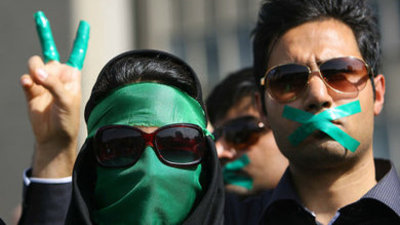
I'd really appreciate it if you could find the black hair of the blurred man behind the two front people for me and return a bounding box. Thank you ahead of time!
[206,68,257,126]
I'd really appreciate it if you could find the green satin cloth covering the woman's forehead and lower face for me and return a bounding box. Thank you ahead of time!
[88,83,207,225]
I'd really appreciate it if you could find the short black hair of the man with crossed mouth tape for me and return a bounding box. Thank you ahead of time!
[253,0,381,105]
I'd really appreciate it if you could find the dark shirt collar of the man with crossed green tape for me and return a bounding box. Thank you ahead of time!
[263,159,400,216]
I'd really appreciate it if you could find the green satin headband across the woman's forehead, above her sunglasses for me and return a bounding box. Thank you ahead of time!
[87,83,210,138]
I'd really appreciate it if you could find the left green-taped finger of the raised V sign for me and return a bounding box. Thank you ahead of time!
[34,11,60,63]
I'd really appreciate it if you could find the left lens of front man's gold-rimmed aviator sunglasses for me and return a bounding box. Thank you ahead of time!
[266,64,309,102]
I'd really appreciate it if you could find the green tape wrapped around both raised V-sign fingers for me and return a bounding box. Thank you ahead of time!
[34,11,90,70]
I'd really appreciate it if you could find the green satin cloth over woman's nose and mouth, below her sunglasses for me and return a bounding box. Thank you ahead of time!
[93,147,202,225]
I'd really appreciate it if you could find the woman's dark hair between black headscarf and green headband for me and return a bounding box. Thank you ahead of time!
[85,50,204,121]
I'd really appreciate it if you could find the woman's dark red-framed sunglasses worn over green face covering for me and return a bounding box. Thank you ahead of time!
[94,123,206,168]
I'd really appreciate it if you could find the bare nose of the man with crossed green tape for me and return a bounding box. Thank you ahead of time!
[304,71,333,113]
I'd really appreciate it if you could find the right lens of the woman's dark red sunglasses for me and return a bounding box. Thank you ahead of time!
[155,126,205,165]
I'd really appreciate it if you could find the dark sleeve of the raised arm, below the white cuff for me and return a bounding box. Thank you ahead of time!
[18,171,72,225]
